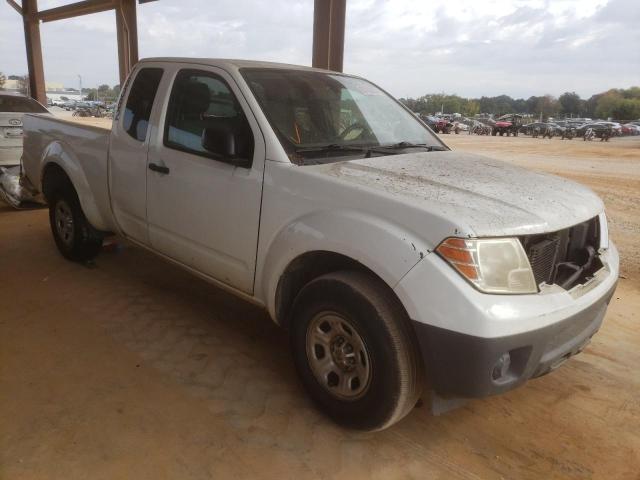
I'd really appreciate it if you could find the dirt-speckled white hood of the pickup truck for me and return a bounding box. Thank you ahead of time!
[311,151,604,236]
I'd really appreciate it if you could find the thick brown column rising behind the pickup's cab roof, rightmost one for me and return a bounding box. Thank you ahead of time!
[312,0,347,72]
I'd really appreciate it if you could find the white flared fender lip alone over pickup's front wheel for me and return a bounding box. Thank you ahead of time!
[255,210,429,319]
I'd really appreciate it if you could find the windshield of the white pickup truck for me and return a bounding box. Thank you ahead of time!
[242,69,445,164]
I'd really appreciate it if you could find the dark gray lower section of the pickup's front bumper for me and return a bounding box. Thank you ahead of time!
[413,285,616,398]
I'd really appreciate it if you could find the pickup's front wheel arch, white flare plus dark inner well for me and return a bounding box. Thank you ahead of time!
[254,210,430,325]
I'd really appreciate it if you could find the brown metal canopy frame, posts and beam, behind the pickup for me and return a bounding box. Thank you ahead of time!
[7,0,347,104]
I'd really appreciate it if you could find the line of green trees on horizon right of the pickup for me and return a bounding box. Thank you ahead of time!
[400,87,640,120]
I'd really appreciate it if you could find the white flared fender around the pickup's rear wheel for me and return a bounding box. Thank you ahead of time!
[40,140,114,231]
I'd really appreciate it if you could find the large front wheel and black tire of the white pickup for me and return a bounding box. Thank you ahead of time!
[290,271,424,431]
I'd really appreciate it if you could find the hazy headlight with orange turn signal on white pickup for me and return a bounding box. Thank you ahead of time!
[436,237,538,293]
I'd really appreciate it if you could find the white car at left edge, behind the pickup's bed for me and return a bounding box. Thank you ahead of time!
[0,92,49,167]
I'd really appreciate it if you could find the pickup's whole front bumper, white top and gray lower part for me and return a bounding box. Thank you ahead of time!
[396,244,619,398]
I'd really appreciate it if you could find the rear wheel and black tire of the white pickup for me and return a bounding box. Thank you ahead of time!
[47,184,103,262]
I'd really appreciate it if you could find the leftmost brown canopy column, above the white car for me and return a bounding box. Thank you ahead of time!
[22,0,47,105]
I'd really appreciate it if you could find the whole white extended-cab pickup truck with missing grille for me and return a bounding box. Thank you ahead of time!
[23,58,619,430]
